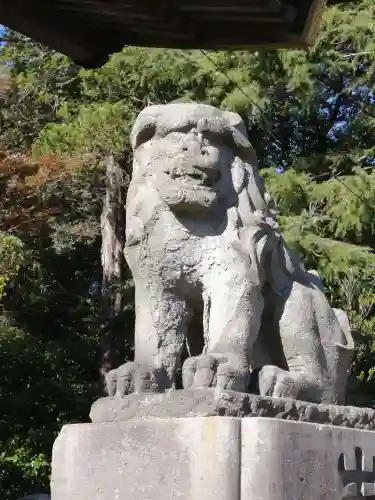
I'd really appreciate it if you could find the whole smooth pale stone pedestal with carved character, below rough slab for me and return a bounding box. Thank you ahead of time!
[52,417,375,500]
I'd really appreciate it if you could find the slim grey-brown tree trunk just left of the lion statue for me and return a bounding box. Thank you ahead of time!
[100,155,125,393]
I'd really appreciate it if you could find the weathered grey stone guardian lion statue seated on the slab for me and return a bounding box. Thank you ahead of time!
[107,104,353,404]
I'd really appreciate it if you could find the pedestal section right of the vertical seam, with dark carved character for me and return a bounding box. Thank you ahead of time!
[241,418,375,500]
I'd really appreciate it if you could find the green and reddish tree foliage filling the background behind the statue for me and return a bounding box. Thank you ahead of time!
[0,0,375,494]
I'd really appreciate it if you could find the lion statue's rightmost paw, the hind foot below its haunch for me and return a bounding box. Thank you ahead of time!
[259,365,322,403]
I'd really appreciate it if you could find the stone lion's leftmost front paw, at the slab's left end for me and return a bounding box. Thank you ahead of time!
[106,361,170,397]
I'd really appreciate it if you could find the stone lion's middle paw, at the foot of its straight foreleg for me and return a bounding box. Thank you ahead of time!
[182,354,250,392]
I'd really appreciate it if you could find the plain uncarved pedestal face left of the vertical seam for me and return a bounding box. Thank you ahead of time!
[51,418,241,500]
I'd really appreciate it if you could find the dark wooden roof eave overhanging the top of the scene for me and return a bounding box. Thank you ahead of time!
[0,0,328,67]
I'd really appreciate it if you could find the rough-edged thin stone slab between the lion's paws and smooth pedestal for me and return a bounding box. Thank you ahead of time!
[90,388,375,431]
